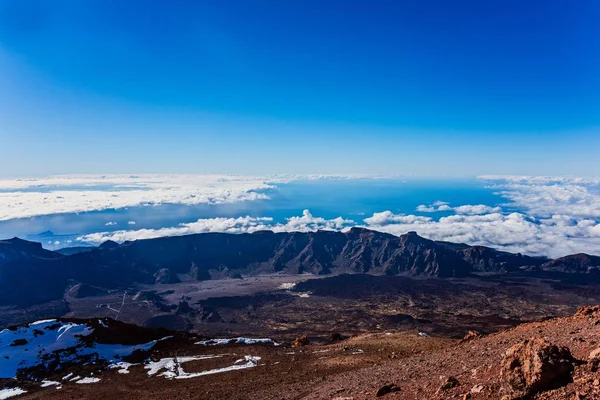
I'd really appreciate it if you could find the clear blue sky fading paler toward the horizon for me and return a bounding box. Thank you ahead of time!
[0,0,600,175]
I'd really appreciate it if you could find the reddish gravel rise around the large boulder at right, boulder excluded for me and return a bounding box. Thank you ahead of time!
[296,313,600,399]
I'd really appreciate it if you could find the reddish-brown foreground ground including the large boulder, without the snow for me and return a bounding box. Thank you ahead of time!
[7,307,600,400]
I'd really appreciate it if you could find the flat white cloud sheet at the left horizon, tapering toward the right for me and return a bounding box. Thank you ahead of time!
[0,175,373,221]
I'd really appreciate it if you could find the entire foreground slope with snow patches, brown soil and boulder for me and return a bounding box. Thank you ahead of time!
[0,306,600,400]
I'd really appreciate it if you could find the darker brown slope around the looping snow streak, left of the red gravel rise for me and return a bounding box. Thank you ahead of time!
[20,332,454,400]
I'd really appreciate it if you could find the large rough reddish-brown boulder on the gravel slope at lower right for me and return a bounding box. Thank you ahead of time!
[502,338,575,398]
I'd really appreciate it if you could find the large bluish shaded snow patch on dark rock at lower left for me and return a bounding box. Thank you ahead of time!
[0,320,156,380]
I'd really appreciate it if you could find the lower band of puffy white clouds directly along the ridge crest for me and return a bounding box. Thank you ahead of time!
[77,205,600,257]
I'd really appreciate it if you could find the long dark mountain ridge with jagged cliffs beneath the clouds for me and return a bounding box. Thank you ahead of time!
[0,228,600,305]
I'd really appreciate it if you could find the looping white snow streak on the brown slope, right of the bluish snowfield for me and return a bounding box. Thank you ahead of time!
[144,354,260,379]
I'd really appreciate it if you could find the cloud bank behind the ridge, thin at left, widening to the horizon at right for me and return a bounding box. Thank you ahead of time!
[79,176,600,257]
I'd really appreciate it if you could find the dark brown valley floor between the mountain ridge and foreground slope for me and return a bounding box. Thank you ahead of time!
[54,275,600,340]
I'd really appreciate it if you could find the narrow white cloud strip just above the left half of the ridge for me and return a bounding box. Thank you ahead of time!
[77,210,355,244]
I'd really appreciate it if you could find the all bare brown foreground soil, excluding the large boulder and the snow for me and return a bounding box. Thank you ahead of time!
[16,312,600,400]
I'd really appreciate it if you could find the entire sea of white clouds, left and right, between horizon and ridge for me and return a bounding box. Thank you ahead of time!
[0,175,600,257]
